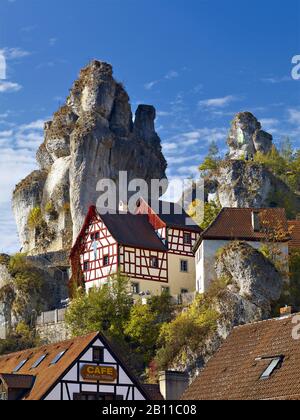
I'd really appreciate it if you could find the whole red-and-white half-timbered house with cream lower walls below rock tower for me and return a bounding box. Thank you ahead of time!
[71,200,201,296]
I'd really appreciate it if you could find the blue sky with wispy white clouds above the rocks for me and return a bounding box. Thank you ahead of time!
[0,0,300,252]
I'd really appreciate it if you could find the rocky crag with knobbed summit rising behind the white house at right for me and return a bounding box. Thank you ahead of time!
[205,112,300,217]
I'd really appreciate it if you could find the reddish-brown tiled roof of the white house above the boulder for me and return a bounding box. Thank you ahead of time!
[201,207,290,242]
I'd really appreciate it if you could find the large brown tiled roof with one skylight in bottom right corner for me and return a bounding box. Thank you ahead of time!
[182,316,300,400]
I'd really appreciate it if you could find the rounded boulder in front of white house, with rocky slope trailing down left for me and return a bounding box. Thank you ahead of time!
[171,242,284,378]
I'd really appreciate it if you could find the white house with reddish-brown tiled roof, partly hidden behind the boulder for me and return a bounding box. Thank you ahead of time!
[194,208,290,293]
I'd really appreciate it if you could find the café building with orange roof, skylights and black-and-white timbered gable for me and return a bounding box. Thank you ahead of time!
[0,333,162,401]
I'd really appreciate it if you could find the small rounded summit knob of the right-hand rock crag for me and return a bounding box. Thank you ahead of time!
[227,112,273,159]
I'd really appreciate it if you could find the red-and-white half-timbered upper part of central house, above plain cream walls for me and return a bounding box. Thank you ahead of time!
[71,200,200,287]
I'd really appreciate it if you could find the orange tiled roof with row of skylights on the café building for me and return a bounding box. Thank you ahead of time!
[0,333,152,400]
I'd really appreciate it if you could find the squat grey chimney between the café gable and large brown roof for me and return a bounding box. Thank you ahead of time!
[159,371,189,401]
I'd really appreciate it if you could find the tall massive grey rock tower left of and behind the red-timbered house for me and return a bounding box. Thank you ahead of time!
[13,61,167,254]
